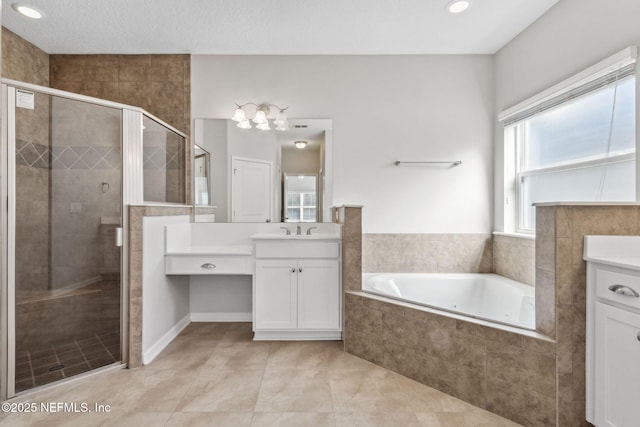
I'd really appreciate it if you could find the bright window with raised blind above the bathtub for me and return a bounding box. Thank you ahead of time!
[504,49,636,232]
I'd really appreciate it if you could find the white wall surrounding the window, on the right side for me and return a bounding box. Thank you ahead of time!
[494,0,640,230]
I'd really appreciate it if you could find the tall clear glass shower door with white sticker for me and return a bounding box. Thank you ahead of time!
[8,88,122,393]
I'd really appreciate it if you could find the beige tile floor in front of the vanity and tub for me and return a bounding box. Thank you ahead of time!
[0,323,517,427]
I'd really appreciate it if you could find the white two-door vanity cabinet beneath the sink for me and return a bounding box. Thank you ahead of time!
[253,241,342,340]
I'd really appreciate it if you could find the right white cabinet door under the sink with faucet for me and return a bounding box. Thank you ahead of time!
[298,260,340,329]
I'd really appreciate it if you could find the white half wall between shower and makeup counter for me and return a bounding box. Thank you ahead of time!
[142,216,190,364]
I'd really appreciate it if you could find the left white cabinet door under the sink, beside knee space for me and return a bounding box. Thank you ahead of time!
[255,259,298,329]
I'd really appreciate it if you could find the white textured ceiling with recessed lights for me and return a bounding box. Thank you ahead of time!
[2,0,558,55]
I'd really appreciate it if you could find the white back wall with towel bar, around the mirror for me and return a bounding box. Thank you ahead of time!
[191,55,494,233]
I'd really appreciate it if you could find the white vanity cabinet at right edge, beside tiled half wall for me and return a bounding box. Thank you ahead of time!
[585,236,640,427]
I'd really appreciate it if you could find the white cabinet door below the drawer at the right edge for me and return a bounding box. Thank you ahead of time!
[594,302,640,427]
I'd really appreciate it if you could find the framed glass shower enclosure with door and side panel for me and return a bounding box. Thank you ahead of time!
[1,81,186,398]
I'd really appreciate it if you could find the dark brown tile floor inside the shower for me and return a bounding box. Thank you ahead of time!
[16,332,120,392]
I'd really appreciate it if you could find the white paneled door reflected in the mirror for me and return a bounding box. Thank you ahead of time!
[231,157,273,222]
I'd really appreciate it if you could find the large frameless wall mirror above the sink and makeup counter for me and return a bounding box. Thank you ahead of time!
[194,119,333,222]
